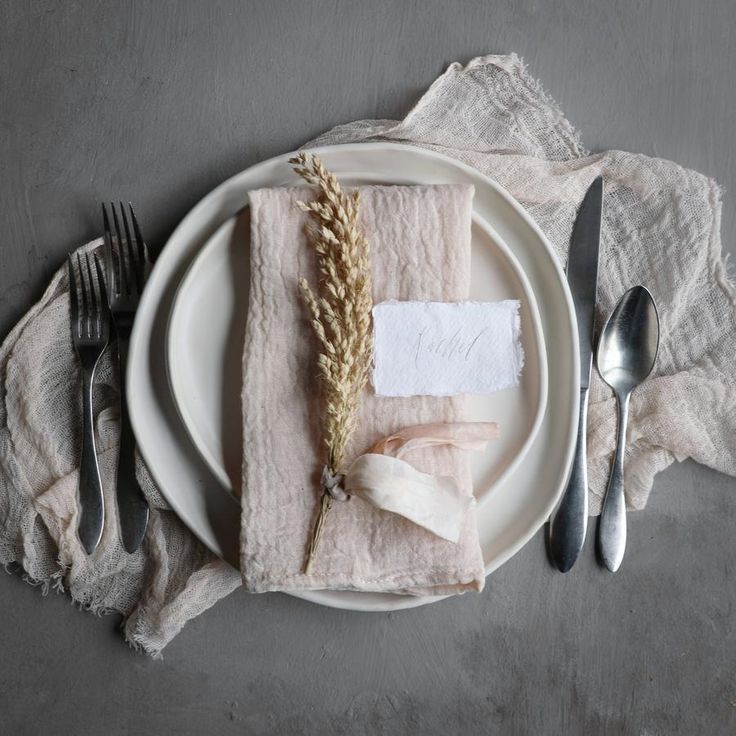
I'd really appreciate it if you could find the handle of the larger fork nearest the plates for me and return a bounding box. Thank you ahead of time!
[116,335,149,552]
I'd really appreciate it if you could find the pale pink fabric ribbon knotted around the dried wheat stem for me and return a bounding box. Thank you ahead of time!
[321,422,498,543]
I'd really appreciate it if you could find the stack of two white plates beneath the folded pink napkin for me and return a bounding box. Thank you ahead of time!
[127,143,579,610]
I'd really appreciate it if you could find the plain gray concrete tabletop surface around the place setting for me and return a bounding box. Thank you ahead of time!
[0,0,736,736]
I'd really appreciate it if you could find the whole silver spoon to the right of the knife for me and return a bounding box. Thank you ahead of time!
[596,286,659,572]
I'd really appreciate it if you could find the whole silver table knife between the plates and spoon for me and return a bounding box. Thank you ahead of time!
[549,176,603,572]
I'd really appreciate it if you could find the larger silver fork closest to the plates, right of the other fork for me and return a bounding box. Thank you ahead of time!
[102,202,148,552]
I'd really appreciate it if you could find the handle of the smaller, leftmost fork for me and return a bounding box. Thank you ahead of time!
[77,366,105,555]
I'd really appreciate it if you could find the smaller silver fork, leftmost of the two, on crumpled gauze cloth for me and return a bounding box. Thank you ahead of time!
[68,251,110,555]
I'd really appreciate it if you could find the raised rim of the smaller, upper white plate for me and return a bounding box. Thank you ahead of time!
[164,206,549,505]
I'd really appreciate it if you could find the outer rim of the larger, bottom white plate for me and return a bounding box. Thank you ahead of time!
[126,141,580,611]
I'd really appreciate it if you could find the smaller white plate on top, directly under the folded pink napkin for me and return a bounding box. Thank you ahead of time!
[166,208,547,503]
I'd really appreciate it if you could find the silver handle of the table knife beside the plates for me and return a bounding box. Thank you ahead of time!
[549,388,588,572]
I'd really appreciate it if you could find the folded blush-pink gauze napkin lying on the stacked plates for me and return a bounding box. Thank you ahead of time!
[241,185,485,594]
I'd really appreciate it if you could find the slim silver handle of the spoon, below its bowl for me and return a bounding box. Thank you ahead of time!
[598,394,629,572]
